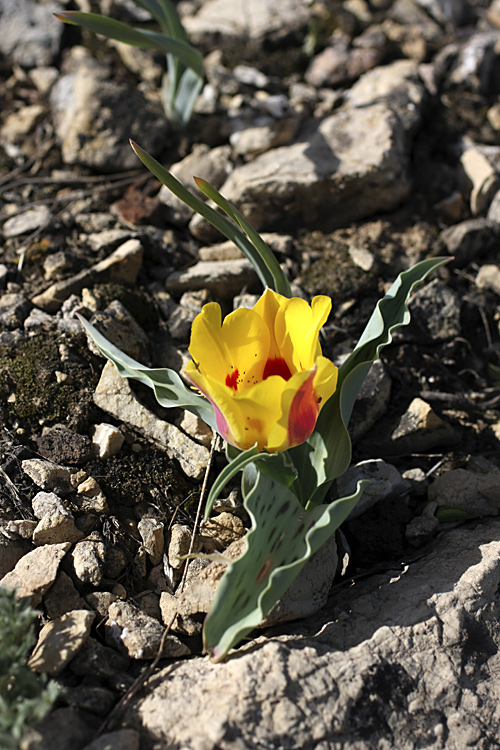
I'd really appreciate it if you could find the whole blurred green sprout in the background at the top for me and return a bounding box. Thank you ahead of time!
[54,0,203,130]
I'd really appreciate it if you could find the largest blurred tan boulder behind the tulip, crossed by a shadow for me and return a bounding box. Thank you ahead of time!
[190,74,423,241]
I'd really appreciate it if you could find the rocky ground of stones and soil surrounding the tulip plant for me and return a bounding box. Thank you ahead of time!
[0,0,500,750]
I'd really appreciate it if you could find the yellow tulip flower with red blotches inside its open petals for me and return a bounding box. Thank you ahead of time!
[186,289,338,453]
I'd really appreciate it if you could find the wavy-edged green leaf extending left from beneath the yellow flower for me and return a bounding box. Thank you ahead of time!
[78,315,217,431]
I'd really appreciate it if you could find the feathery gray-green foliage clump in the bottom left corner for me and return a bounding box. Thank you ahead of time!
[0,587,59,750]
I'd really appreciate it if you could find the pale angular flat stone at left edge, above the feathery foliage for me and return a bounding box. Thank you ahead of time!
[0,542,71,607]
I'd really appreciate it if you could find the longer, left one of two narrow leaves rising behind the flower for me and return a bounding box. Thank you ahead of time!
[130,141,290,292]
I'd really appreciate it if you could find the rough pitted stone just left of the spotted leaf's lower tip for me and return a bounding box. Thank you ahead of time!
[105,602,191,659]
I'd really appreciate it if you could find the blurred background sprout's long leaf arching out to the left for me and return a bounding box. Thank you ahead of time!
[54,10,203,77]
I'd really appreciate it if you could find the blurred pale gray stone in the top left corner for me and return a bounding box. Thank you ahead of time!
[0,0,63,68]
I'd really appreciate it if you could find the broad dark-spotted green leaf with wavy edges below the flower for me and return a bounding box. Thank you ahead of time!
[203,472,368,661]
